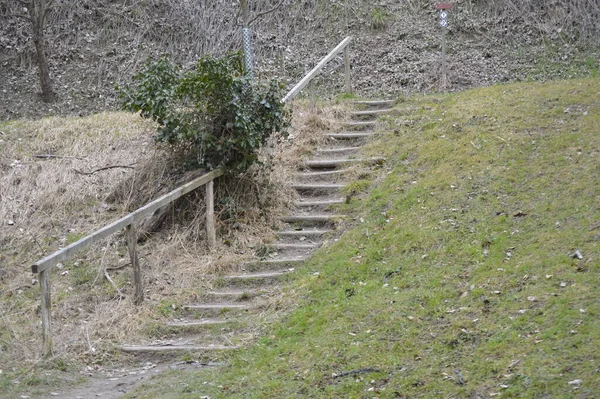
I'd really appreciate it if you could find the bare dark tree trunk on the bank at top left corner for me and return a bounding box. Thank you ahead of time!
[3,0,56,102]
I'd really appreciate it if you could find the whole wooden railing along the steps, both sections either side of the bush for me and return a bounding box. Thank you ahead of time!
[31,37,352,357]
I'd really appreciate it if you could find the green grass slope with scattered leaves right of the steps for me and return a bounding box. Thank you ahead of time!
[122,79,600,398]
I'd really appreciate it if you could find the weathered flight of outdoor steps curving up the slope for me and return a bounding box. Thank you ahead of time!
[120,100,394,354]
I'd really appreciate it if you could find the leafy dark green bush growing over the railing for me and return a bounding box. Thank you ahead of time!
[117,53,290,172]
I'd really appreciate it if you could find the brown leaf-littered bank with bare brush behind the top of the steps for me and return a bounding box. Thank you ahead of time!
[0,0,600,120]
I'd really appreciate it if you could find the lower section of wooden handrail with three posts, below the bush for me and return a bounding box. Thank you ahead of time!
[31,169,224,357]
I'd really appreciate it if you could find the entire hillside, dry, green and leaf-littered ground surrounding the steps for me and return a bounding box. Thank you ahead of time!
[0,0,600,398]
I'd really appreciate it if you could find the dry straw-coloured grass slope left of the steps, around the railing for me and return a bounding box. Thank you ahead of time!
[0,102,342,388]
